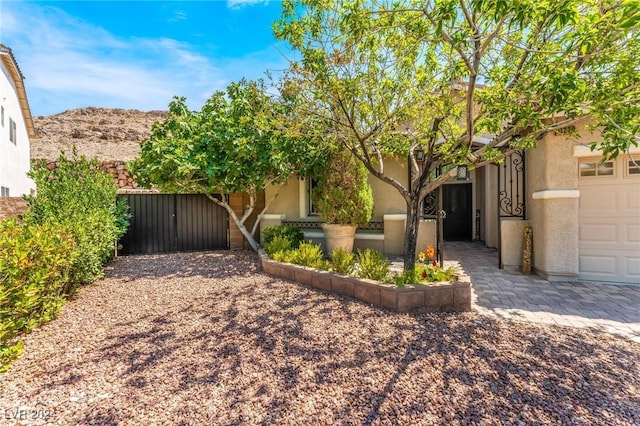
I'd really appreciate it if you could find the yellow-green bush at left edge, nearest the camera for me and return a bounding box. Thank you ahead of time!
[0,219,78,372]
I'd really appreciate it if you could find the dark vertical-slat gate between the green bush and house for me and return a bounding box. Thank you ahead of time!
[120,194,229,254]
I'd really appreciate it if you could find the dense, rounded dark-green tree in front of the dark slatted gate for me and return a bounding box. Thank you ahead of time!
[131,80,328,251]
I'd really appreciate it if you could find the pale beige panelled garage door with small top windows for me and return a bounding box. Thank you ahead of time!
[578,155,640,284]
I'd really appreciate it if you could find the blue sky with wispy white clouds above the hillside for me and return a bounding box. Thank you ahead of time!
[0,0,293,116]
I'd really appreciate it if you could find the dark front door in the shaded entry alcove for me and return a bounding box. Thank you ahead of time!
[442,183,472,241]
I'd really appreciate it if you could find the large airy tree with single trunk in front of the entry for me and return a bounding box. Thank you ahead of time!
[274,0,640,269]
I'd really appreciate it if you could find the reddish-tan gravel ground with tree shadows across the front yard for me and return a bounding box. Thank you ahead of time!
[0,252,640,425]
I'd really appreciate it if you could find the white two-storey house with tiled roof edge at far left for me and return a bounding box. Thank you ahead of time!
[0,44,35,197]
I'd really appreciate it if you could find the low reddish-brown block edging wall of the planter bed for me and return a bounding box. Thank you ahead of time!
[258,250,471,312]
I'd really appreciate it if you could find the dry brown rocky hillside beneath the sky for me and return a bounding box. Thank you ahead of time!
[31,107,166,162]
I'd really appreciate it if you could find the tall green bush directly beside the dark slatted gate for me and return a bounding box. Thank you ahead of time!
[24,149,129,287]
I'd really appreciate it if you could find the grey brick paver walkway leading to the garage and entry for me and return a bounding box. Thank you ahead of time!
[444,242,640,343]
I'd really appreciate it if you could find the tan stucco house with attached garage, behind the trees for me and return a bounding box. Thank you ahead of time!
[261,121,640,283]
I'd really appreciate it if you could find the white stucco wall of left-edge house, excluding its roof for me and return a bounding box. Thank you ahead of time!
[0,61,35,197]
